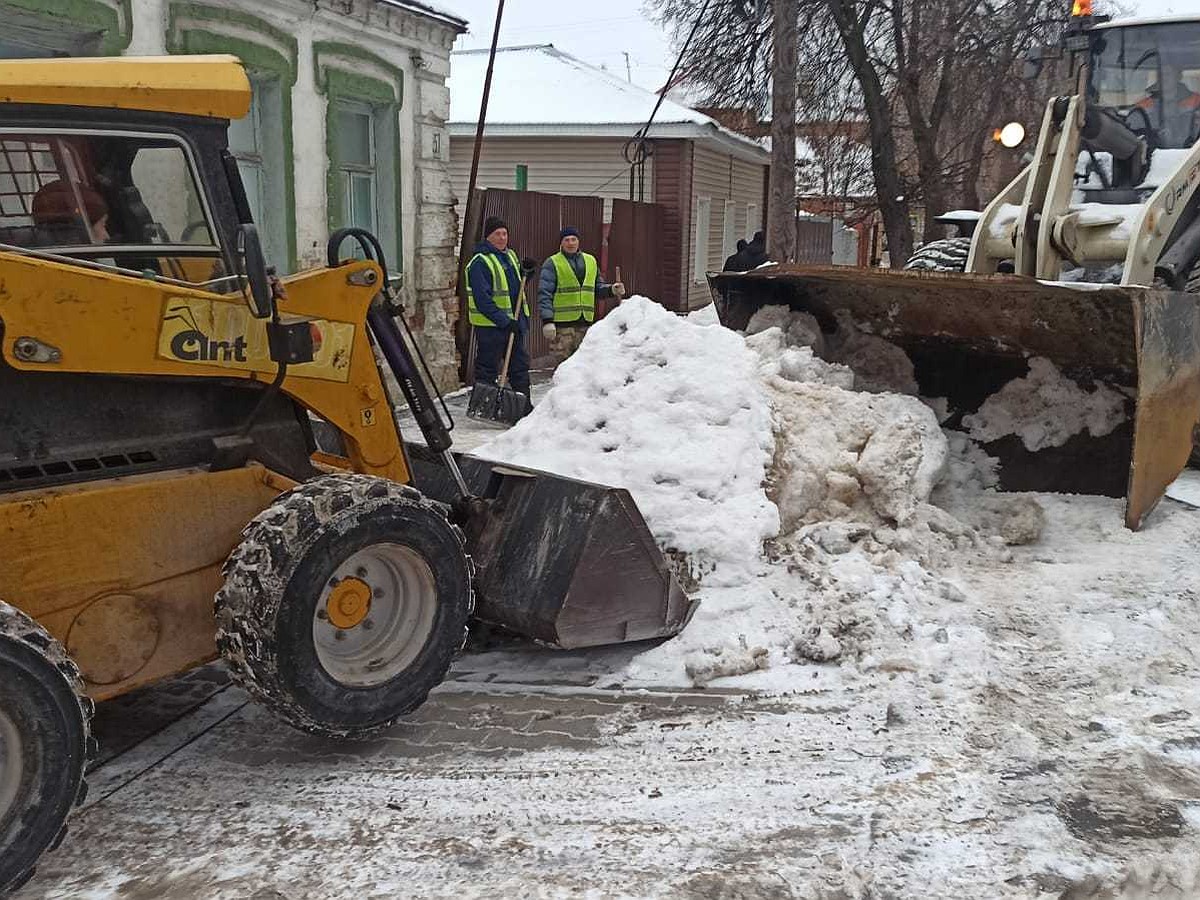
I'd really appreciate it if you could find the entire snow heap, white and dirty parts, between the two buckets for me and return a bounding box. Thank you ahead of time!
[476,298,1040,684]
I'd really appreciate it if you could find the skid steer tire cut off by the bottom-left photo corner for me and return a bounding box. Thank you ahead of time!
[0,601,95,896]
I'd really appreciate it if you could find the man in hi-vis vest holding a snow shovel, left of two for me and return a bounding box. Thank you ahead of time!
[467,216,535,396]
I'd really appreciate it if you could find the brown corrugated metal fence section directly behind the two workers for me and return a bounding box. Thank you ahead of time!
[457,187,604,384]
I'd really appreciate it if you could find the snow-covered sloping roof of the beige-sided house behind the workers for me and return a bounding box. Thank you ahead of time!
[449,44,767,162]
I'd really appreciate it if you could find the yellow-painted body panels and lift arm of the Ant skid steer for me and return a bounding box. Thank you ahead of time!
[0,254,409,700]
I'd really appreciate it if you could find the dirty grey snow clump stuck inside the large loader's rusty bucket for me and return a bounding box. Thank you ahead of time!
[962,356,1128,451]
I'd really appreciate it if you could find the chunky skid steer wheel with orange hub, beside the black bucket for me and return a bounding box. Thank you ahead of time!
[216,475,473,739]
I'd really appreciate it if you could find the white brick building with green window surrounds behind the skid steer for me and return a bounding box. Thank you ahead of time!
[0,0,466,386]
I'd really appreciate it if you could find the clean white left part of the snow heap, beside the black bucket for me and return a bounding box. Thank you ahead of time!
[475,296,797,684]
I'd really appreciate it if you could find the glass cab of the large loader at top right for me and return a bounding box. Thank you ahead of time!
[1087,17,1200,150]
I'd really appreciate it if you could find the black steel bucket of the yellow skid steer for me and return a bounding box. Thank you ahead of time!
[408,445,696,649]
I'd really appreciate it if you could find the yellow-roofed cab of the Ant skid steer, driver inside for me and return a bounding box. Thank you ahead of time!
[0,56,261,293]
